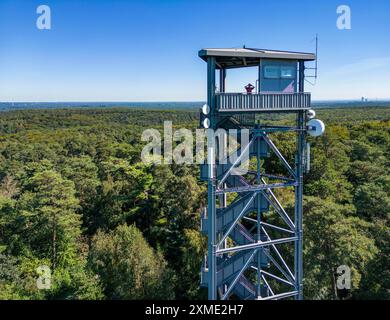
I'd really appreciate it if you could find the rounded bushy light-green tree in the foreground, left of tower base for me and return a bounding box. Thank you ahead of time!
[90,225,175,299]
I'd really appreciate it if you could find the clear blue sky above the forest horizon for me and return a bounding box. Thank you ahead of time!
[0,0,390,101]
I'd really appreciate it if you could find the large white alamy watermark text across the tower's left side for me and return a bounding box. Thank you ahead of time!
[141,121,250,175]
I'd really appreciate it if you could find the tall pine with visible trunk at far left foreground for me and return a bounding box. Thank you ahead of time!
[18,170,81,269]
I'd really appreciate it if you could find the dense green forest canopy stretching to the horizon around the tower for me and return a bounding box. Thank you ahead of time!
[0,108,390,299]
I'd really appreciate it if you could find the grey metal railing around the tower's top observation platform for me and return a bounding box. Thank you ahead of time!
[215,92,311,111]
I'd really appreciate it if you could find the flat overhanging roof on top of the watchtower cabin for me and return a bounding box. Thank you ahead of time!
[199,48,316,69]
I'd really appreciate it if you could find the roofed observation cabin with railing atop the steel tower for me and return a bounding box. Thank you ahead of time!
[199,48,316,112]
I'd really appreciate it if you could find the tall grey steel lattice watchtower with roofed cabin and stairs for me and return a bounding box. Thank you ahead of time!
[199,48,324,300]
